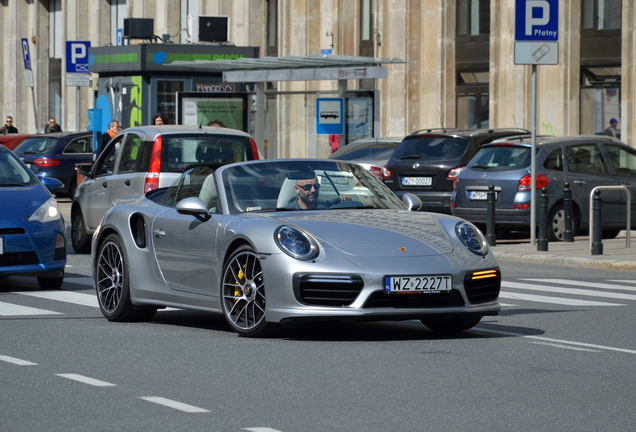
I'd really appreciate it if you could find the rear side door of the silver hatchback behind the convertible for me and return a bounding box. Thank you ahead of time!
[108,132,145,203]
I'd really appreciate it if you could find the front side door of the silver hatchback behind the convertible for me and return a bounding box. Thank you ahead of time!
[80,136,123,230]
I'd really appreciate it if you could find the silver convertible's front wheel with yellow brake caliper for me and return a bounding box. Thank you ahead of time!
[221,245,278,337]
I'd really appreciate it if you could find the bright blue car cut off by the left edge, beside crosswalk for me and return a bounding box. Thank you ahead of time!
[0,146,66,289]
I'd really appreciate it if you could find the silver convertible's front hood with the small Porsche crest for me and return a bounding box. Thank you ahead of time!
[258,210,453,258]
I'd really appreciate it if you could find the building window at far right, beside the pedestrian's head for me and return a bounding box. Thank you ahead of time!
[580,67,621,138]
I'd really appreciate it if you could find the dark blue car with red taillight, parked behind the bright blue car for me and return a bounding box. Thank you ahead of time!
[13,132,93,198]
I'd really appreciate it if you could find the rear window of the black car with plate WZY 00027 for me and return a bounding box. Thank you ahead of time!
[393,136,468,161]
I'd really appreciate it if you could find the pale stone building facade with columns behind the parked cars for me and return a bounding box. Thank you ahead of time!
[0,0,636,157]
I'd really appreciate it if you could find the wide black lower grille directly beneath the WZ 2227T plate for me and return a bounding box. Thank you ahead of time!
[364,290,465,309]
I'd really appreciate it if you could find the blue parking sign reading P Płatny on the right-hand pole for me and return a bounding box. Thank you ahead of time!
[515,0,559,42]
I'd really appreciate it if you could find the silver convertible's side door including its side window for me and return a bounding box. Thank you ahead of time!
[152,167,222,297]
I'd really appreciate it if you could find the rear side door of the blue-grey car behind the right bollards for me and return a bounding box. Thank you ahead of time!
[565,142,621,227]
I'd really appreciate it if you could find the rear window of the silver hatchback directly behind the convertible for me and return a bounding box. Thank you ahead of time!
[161,134,254,172]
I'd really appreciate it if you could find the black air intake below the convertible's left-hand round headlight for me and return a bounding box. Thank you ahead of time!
[294,275,364,306]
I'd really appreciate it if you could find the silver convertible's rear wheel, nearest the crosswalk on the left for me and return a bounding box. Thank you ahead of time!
[95,234,157,321]
